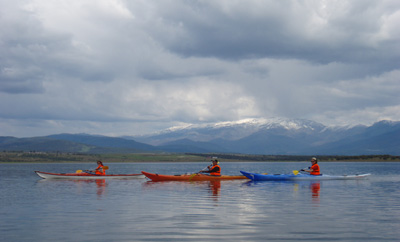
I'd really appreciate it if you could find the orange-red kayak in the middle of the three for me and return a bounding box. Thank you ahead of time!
[142,171,247,181]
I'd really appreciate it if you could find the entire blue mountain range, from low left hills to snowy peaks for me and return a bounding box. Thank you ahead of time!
[0,119,400,155]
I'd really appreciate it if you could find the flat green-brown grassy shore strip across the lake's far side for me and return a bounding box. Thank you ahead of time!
[0,152,400,164]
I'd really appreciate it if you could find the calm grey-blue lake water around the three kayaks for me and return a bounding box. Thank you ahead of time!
[0,162,400,242]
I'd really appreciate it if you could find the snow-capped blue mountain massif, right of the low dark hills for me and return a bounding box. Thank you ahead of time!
[134,118,400,155]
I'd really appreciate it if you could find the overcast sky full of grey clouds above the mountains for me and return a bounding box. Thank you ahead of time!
[0,0,400,137]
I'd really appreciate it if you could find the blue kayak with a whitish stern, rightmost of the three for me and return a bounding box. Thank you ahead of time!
[240,171,371,181]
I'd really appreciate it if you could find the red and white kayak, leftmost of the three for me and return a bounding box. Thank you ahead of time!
[35,171,144,179]
